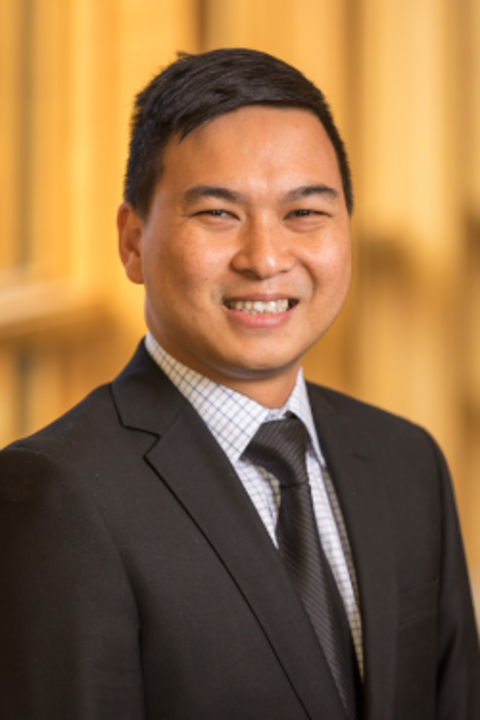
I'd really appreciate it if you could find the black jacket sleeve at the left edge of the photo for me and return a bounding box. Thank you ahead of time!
[0,446,145,720]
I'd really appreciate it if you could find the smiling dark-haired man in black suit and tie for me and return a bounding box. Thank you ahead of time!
[0,50,480,720]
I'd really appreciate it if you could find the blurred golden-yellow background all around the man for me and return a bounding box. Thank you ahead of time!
[0,0,480,594]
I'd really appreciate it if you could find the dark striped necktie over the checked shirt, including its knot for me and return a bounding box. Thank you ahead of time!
[244,416,361,720]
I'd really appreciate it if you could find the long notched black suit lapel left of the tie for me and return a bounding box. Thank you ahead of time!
[113,346,345,720]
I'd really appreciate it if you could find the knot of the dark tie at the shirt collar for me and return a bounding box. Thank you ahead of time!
[243,417,308,487]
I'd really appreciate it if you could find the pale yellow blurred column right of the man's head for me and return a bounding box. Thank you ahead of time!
[357,0,462,444]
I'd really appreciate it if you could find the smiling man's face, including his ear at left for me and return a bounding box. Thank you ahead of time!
[119,107,351,404]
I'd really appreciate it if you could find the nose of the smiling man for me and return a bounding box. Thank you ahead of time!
[232,220,295,280]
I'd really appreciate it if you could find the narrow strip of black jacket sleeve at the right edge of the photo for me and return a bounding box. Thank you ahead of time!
[435,446,480,720]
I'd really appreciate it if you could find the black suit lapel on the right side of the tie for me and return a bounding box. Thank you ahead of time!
[310,388,398,720]
